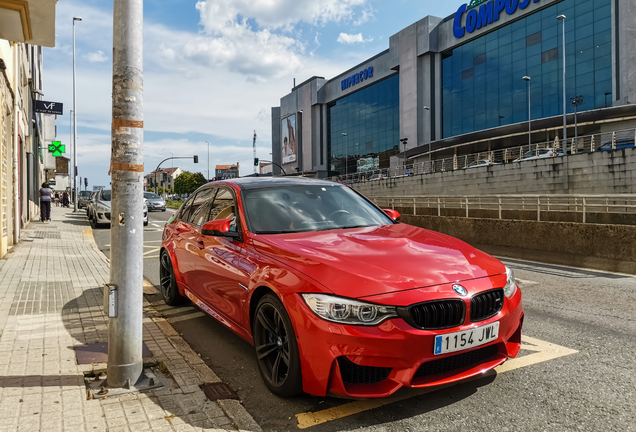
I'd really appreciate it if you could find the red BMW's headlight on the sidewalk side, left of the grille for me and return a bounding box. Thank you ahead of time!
[303,294,398,325]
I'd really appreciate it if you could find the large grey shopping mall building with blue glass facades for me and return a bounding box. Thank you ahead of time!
[272,0,636,177]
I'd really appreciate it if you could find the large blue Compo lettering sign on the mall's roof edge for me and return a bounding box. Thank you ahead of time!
[453,0,539,39]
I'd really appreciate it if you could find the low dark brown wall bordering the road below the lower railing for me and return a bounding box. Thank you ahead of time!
[402,214,636,274]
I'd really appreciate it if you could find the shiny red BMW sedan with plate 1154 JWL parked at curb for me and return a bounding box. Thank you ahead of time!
[160,177,523,398]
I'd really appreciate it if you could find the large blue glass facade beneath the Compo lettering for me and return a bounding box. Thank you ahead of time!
[442,0,612,138]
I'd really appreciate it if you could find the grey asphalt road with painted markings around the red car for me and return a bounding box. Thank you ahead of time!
[94,216,636,432]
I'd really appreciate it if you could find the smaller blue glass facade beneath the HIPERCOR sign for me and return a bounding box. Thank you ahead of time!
[327,74,400,174]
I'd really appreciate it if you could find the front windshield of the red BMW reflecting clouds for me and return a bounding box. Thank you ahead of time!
[243,184,393,234]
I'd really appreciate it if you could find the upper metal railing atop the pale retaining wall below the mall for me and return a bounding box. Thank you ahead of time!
[331,129,636,183]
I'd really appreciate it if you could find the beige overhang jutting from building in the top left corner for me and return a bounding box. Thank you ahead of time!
[0,0,57,47]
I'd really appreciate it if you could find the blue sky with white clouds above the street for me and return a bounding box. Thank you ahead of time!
[43,0,464,189]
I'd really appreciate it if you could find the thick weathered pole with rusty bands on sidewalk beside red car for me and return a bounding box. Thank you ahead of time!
[107,0,144,388]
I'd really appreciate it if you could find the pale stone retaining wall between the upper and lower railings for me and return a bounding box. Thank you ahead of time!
[353,147,636,197]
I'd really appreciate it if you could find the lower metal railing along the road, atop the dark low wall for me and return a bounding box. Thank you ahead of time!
[369,194,636,223]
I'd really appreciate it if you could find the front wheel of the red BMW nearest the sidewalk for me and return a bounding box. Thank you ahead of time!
[252,294,303,398]
